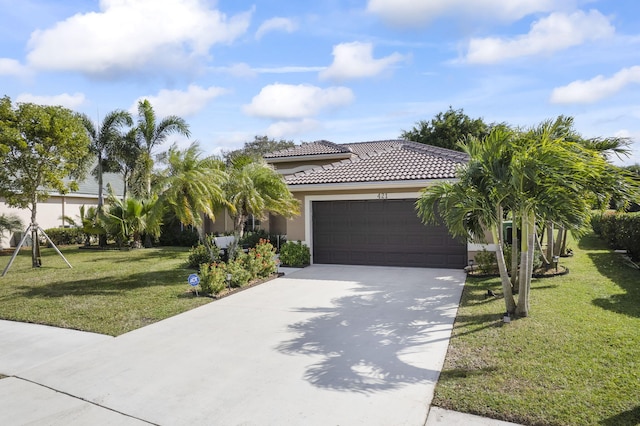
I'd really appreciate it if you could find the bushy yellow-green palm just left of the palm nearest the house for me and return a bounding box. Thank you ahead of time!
[159,142,227,236]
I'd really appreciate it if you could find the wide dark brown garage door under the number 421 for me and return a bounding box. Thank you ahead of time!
[312,200,467,268]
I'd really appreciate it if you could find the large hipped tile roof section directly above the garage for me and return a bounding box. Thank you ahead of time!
[285,140,468,185]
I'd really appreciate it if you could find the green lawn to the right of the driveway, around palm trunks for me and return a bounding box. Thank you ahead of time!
[433,235,640,426]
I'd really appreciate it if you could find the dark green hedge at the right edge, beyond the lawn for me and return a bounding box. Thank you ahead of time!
[591,213,640,260]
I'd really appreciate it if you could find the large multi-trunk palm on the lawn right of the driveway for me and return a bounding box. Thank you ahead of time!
[417,119,638,316]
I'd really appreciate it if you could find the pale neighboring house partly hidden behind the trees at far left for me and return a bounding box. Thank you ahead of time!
[0,173,124,247]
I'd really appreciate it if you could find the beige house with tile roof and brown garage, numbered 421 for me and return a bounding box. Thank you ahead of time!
[205,140,475,268]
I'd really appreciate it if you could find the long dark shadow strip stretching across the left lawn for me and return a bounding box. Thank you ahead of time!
[12,270,186,298]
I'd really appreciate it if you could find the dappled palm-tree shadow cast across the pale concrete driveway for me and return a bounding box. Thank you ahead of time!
[278,268,464,393]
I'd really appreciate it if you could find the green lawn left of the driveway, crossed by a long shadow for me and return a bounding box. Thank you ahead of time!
[0,246,211,336]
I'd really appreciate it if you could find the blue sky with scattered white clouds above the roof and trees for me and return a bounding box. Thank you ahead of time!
[0,0,640,164]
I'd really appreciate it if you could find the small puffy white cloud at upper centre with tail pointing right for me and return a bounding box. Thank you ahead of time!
[320,41,404,80]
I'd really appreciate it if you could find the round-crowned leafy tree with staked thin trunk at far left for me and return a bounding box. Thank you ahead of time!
[0,97,90,267]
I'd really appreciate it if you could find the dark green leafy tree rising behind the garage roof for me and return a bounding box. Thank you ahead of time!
[400,107,491,151]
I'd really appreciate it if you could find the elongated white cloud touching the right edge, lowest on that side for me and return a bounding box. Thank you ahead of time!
[550,66,640,104]
